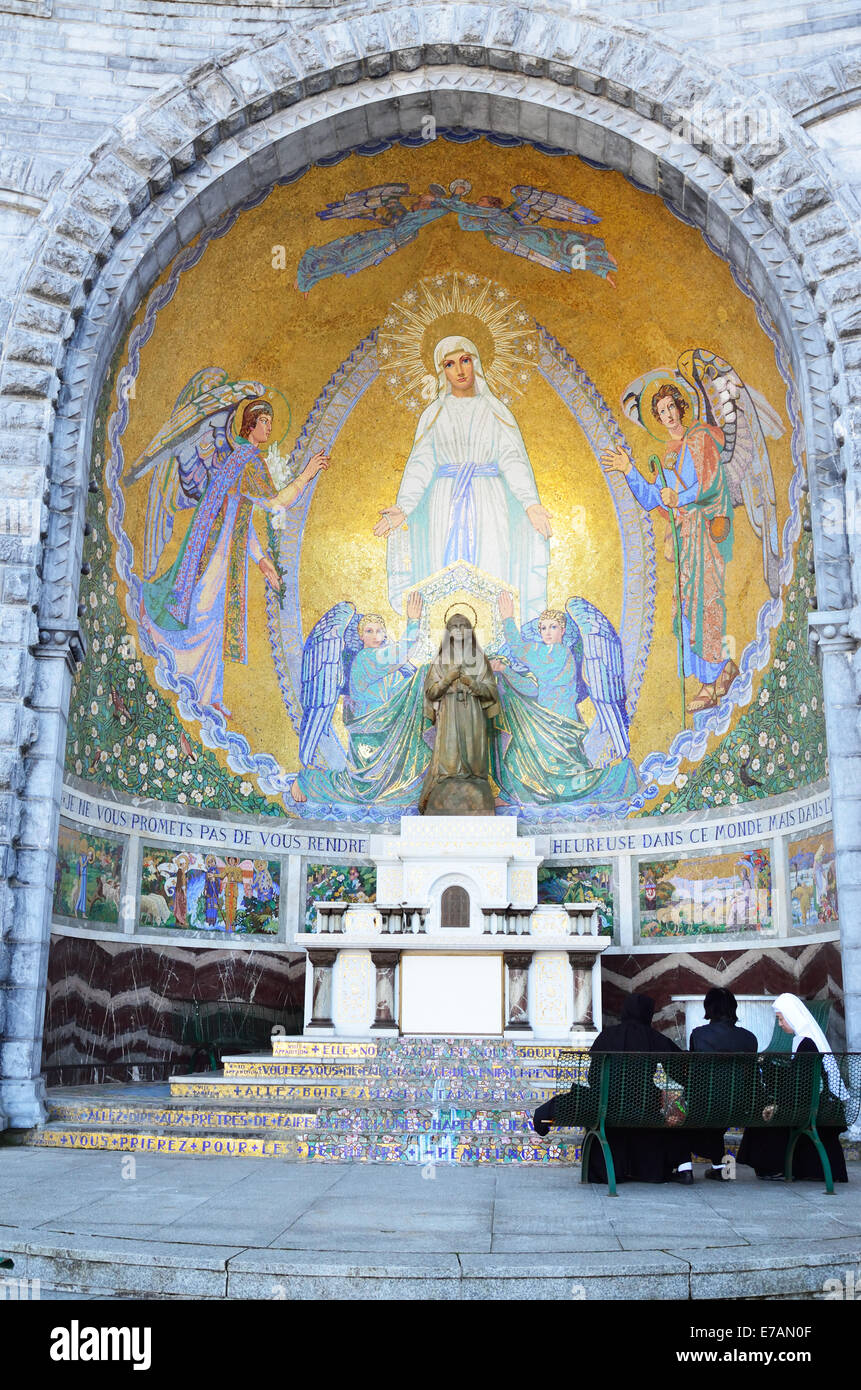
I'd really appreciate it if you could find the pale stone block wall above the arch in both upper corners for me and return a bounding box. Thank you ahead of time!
[0,0,861,207]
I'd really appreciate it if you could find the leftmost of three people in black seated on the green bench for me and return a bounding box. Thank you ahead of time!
[533,994,689,1183]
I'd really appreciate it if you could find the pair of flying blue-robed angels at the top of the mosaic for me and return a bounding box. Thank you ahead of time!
[296,179,618,293]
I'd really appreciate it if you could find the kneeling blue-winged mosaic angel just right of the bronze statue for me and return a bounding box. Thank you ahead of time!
[491,591,637,803]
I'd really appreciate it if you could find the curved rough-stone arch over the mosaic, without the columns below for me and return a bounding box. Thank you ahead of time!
[6,6,861,630]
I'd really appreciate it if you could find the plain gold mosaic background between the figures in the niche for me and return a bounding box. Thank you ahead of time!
[116,140,791,795]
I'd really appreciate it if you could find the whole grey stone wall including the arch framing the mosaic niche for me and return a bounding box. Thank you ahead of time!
[0,0,861,1125]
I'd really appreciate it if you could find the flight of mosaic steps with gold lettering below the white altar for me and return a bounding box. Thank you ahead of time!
[13,1036,592,1163]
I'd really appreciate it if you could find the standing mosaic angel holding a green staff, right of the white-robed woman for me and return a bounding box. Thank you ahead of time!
[601,348,783,714]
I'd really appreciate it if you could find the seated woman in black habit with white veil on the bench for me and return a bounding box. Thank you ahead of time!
[737,994,850,1183]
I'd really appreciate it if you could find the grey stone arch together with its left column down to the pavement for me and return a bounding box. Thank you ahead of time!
[0,3,861,1123]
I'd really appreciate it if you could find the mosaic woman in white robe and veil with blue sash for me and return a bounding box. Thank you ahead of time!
[374,335,552,623]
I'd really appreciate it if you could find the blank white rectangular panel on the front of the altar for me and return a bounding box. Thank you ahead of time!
[401,951,502,1037]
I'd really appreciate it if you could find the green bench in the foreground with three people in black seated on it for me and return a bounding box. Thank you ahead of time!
[555,1049,861,1197]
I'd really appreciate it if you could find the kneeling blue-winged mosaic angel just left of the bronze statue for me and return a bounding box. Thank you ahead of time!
[291,594,430,805]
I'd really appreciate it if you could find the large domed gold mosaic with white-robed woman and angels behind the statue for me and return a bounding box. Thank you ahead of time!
[67,139,825,824]
